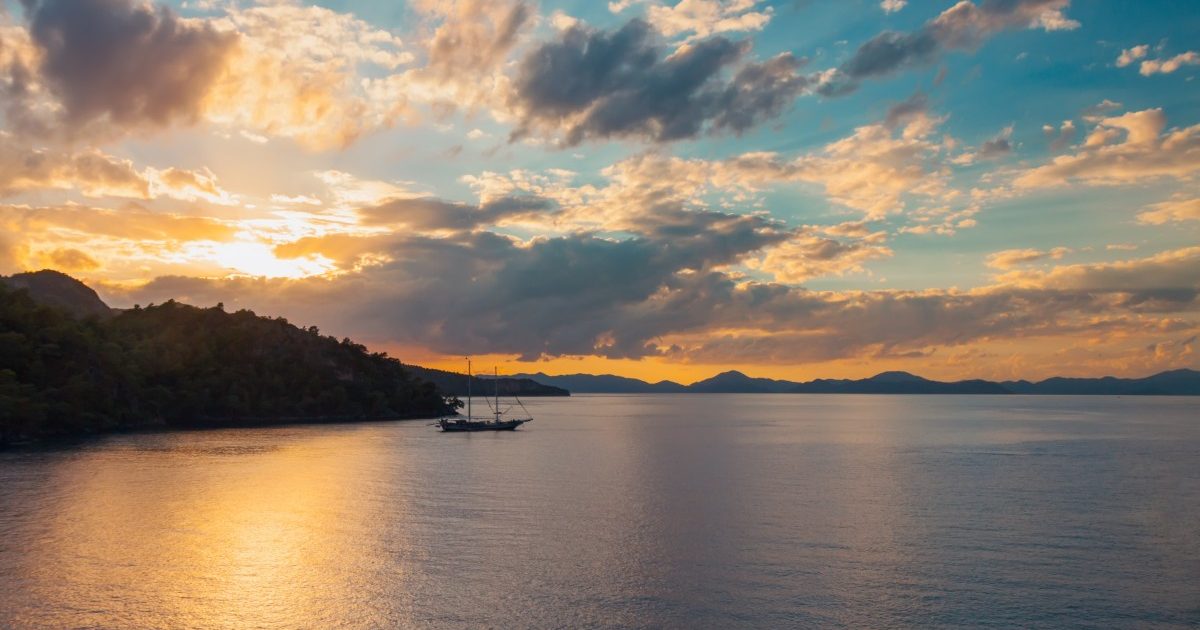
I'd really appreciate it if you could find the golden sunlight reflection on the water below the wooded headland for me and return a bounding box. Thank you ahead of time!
[15,430,422,628]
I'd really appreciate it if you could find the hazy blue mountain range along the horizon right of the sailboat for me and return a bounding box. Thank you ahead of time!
[511,370,1200,396]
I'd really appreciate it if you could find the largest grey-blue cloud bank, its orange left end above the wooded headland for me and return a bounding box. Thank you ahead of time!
[128,206,790,358]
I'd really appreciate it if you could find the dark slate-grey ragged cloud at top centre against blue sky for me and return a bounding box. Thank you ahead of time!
[511,19,808,145]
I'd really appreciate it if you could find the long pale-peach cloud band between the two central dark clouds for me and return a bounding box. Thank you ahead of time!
[464,103,977,228]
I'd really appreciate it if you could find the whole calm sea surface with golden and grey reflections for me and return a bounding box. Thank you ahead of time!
[0,395,1200,628]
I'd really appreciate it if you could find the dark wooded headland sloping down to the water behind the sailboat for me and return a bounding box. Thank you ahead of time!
[0,270,556,446]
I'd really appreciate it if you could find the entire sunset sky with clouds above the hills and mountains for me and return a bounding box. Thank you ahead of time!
[0,0,1200,383]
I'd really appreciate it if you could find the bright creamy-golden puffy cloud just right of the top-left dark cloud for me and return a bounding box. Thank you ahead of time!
[204,2,422,150]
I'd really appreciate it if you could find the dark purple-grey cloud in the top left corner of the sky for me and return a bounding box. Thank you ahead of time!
[23,0,235,128]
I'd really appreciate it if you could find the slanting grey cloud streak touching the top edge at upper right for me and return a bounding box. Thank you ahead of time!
[823,0,1079,96]
